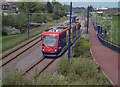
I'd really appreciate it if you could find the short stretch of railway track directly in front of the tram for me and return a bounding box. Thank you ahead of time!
[22,57,57,78]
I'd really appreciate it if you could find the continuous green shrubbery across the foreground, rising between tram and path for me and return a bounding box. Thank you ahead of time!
[3,35,110,85]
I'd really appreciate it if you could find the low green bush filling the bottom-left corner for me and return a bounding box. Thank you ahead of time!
[2,70,32,85]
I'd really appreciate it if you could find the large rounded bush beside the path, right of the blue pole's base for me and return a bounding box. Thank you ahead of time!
[68,58,98,81]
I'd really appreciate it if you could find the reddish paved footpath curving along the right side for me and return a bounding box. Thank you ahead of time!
[89,21,120,86]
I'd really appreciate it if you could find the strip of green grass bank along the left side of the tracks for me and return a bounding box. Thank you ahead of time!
[2,18,66,52]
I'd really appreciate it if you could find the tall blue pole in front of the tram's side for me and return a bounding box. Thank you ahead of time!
[68,2,72,60]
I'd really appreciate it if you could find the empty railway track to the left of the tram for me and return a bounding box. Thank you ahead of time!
[0,35,41,67]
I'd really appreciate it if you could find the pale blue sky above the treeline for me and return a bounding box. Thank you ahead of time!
[4,0,120,8]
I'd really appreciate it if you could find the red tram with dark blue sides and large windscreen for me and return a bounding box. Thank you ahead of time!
[42,22,81,57]
